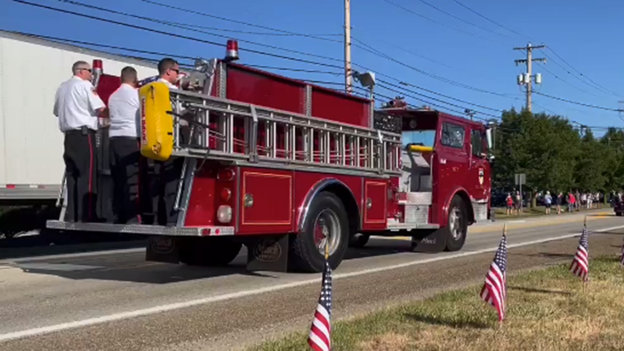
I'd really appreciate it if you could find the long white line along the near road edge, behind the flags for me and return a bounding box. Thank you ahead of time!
[0,225,624,342]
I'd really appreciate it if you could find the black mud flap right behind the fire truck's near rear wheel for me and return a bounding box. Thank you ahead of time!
[247,234,289,272]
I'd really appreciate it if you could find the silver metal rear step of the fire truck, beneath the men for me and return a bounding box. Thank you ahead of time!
[46,221,234,236]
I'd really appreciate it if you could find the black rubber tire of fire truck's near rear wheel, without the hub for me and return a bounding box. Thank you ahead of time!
[291,192,349,273]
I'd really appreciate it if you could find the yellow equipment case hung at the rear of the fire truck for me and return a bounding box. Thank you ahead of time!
[139,82,173,161]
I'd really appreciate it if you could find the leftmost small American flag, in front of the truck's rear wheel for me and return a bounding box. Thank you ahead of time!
[308,247,332,351]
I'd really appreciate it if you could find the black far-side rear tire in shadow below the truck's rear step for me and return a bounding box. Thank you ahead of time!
[178,238,243,266]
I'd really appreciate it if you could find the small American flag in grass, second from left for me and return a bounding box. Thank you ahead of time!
[481,234,507,321]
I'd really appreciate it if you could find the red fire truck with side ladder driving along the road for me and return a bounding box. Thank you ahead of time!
[47,42,491,272]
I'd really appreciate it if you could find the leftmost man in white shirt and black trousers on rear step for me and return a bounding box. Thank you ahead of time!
[54,61,106,222]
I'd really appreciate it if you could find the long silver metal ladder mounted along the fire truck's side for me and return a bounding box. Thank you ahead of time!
[170,91,401,225]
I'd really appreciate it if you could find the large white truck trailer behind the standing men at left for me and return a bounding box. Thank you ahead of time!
[0,31,157,237]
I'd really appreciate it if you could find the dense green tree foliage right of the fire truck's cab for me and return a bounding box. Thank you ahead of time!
[492,109,624,192]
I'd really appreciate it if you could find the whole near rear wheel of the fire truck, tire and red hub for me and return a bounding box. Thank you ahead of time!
[292,192,349,272]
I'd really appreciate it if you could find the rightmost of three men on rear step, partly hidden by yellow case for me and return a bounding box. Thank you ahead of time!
[153,58,189,226]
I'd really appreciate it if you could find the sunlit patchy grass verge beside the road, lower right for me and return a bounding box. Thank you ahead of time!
[250,257,624,351]
